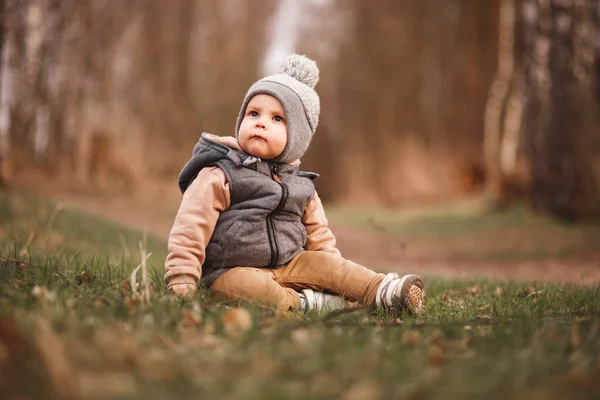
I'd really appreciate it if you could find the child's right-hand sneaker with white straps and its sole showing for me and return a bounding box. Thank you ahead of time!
[375,272,427,315]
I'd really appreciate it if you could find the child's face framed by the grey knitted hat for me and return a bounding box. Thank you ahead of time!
[238,94,287,160]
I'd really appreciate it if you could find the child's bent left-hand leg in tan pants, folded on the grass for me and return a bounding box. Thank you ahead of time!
[210,267,300,311]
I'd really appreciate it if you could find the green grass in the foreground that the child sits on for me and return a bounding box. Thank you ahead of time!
[0,189,600,399]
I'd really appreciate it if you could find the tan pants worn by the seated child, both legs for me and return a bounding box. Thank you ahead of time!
[210,251,385,310]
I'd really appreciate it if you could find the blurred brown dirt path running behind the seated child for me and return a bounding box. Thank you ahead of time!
[53,195,600,284]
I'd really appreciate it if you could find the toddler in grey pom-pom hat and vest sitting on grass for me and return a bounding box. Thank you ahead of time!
[165,54,425,314]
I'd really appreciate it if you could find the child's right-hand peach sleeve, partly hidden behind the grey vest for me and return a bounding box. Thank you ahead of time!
[302,191,340,255]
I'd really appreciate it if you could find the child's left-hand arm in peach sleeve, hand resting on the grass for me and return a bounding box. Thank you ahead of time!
[165,167,231,295]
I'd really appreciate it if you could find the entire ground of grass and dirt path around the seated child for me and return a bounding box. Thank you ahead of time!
[0,190,600,400]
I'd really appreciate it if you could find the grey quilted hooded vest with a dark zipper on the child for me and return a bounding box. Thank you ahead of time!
[179,136,318,287]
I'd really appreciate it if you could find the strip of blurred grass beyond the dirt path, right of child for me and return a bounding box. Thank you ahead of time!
[327,201,600,263]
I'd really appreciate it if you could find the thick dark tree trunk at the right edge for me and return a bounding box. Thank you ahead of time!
[520,0,600,220]
